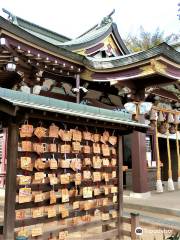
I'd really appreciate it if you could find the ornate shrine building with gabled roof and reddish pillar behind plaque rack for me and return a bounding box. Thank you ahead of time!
[0,8,180,193]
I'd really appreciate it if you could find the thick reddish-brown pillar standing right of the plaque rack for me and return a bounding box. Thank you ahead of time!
[131,131,149,193]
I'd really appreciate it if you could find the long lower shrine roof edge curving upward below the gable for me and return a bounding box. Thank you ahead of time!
[0,17,180,71]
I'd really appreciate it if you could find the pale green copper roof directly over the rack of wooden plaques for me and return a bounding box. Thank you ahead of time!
[0,88,148,128]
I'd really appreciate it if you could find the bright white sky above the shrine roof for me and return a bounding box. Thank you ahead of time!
[0,0,180,38]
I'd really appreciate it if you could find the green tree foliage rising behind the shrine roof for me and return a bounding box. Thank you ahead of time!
[124,26,179,52]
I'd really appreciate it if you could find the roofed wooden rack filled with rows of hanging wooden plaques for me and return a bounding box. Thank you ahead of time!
[0,88,147,240]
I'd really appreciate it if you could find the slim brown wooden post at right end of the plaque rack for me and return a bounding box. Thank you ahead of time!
[118,136,123,240]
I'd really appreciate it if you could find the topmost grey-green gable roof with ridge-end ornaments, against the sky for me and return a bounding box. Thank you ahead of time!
[4,10,129,54]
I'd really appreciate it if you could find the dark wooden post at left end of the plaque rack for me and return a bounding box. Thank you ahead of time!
[3,123,18,240]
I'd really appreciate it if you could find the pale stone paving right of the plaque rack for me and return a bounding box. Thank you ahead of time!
[124,190,180,240]
